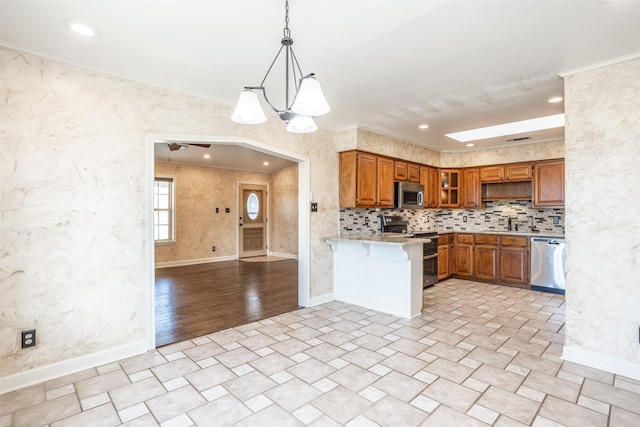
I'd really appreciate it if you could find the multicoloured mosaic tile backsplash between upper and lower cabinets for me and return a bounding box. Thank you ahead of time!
[340,200,565,235]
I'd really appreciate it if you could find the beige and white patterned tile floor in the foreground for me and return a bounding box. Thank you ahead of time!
[0,279,640,427]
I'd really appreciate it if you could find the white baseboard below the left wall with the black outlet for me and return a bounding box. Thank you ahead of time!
[0,341,149,394]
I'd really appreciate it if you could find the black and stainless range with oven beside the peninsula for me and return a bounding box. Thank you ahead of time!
[380,215,438,288]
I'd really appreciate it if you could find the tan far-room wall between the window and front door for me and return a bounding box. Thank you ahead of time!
[155,162,274,263]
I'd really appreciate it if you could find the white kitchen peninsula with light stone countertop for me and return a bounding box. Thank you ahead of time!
[324,233,430,318]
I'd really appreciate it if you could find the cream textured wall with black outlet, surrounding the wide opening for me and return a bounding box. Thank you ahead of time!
[0,48,339,377]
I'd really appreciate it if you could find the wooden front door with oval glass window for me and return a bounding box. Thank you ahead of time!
[238,184,267,258]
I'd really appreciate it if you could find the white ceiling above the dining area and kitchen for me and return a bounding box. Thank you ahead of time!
[0,0,640,161]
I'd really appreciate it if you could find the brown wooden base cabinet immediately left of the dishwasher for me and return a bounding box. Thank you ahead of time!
[498,236,529,285]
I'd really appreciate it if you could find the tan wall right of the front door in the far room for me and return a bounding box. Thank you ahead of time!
[269,163,298,255]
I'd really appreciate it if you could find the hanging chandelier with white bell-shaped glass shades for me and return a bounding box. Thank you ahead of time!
[231,0,330,133]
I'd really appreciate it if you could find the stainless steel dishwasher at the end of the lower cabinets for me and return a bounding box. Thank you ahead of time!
[530,237,565,295]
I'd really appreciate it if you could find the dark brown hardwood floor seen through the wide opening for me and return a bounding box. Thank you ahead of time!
[155,259,298,347]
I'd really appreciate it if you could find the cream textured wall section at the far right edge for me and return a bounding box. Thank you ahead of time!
[564,59,640,379]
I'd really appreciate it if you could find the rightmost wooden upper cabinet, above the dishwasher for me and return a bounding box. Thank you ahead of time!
[533,159,564,208]
